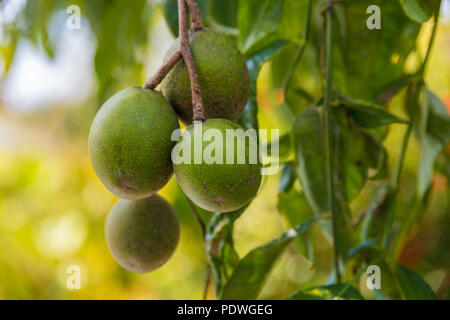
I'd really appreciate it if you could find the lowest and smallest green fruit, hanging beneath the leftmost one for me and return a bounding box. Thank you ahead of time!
[105,194,180,273]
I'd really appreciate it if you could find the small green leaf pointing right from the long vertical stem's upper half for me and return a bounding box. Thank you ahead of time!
[334,97,408,128]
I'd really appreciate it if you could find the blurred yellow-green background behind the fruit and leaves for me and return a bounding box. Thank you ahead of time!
[0,0,450,299]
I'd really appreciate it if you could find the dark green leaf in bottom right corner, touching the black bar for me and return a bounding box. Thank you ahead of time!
[392,264,438,300]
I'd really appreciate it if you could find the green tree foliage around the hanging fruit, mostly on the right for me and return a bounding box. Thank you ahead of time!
[1,0,450,300]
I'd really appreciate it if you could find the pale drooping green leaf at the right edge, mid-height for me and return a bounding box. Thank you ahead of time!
[415,88,450,198]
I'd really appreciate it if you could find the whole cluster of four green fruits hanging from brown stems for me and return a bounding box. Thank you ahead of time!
[89,29,261,273]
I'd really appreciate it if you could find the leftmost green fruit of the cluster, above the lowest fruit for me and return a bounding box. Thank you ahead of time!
[89,87,179,199]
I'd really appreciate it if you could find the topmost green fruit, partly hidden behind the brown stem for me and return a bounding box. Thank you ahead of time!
[161,29,250,124]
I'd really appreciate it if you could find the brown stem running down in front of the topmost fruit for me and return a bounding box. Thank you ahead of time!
[178,0,205,121]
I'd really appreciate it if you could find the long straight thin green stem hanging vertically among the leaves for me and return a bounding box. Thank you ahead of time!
[323,1,341,283]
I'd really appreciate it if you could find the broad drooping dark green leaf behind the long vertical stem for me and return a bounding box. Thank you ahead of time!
[294,107,383,213]
